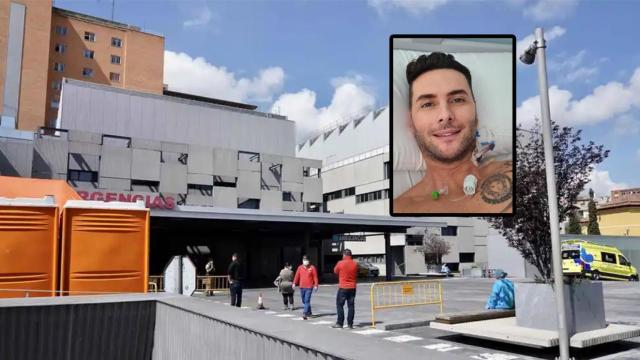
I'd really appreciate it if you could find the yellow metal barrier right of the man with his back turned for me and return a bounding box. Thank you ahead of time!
[370,280,444,327]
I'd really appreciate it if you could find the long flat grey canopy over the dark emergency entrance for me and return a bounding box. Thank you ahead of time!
[151,206,447,236]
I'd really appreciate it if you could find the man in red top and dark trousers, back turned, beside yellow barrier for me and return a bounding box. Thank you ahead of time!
[332,249,358,329]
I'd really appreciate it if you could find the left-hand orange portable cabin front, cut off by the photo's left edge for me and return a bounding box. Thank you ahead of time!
[0,197,58,298]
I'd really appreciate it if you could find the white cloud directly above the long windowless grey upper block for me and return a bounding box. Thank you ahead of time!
[164,50,285,102]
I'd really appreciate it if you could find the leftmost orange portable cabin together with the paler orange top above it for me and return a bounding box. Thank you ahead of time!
[0,176,80,298]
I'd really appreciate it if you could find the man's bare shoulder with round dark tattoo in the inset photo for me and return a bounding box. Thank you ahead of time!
[479,161,513,213]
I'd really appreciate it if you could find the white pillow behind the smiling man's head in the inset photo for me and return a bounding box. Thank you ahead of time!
[392,50,513,173]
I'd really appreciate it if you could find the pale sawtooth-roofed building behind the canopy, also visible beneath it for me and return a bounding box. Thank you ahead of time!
[297,109,489,274]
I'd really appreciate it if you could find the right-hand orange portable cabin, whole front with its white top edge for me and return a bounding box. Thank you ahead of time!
[60,200,149,295]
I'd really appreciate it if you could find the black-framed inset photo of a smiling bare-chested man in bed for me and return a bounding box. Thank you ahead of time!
[390,35,516,216]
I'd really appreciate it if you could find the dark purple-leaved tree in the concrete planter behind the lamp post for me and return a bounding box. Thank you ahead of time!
[488,122,609,282]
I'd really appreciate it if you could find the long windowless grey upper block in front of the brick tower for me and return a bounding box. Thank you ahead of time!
[60,80,301,159]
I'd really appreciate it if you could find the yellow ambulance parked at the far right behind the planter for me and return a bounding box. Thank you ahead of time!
[562,240,638,281]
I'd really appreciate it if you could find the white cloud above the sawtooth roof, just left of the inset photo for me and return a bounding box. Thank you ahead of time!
[271,76,375,140]
